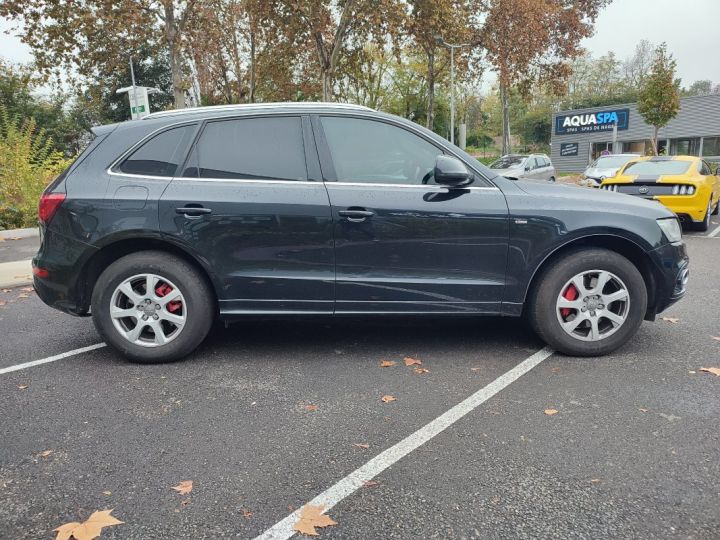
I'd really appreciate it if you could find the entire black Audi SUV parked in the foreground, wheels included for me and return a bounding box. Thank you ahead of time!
[33,103,688,362]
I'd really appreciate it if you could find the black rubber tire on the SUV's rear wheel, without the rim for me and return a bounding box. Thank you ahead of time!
[91,251,215,364]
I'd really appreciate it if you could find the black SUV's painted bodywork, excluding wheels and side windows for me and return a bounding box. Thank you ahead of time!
[34,104,688,324]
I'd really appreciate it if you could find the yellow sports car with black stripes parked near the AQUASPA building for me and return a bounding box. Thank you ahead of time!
[601,156,720,231]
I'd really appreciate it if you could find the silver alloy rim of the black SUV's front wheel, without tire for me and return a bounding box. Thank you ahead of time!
[555,270,630,341]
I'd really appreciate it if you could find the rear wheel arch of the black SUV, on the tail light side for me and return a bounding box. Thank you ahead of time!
[76,237,219,313]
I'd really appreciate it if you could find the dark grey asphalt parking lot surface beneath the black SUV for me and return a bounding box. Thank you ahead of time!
[0,229,720,539]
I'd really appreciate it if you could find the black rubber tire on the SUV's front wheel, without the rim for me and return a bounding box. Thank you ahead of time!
[527,248,648,356]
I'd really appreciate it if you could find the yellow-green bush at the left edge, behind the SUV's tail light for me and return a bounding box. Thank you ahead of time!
[0,104,70,229]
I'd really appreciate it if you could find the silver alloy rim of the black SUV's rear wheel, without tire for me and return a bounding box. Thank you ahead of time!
[110,274,187,347]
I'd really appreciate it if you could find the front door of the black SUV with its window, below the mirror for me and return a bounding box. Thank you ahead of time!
[313,115,508,313]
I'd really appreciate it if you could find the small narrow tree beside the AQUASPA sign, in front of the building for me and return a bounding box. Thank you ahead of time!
[638,43,680,155]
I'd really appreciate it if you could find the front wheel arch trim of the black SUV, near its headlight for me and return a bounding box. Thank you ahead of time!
[523,234,658,319]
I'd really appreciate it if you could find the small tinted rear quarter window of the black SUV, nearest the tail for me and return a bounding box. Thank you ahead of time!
[118,124,196,176]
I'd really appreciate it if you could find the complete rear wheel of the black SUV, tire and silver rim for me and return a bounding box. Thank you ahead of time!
[92,251,214,363]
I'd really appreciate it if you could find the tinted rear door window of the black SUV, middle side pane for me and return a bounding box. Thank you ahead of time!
[184,117,307,180]
